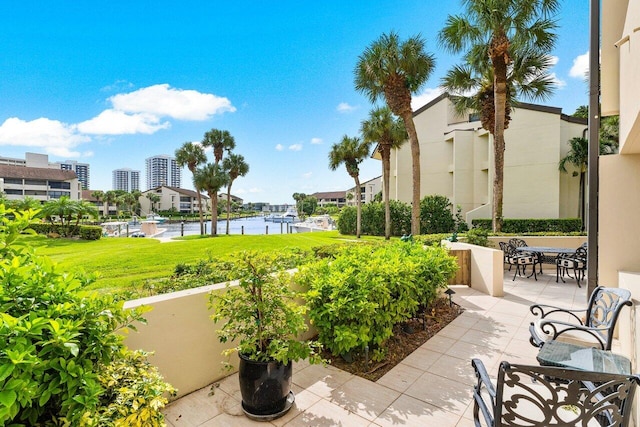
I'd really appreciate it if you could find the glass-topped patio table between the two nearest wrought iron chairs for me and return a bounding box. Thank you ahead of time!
[537,340,631,375]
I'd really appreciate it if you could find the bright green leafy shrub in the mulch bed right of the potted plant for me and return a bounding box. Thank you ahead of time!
[295,242,457,359]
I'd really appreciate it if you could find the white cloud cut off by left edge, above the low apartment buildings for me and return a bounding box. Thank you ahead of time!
[0,117,91,158]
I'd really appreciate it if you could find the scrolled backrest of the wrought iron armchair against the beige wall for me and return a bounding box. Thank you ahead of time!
[585,286,632,336]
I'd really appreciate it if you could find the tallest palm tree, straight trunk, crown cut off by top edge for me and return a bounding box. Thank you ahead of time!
[439,0,559,231]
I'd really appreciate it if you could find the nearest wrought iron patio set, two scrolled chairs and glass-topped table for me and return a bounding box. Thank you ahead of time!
[471,287,640,427]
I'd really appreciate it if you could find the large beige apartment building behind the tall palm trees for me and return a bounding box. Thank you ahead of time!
[389,94,587,223]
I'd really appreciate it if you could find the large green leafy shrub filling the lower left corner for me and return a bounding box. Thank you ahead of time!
[0,205,173,426]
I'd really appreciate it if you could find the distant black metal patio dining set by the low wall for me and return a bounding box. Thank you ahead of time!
[499,238,587,287]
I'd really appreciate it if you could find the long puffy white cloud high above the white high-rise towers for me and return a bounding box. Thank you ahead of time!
[109,84,236,120]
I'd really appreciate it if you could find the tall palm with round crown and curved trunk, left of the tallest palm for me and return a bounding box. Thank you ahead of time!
[355,32,435,235]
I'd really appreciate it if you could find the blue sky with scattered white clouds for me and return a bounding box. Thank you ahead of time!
[0,0,589,204]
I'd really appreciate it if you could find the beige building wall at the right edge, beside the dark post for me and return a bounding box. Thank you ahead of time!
[598,0,640,426]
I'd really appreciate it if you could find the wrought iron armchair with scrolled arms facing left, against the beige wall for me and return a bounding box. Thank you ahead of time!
[529,286,632,350]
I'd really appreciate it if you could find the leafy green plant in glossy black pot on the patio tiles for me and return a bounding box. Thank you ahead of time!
[210,251,322,420]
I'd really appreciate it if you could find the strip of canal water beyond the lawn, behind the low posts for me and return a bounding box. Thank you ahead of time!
[158,216,296,237]
